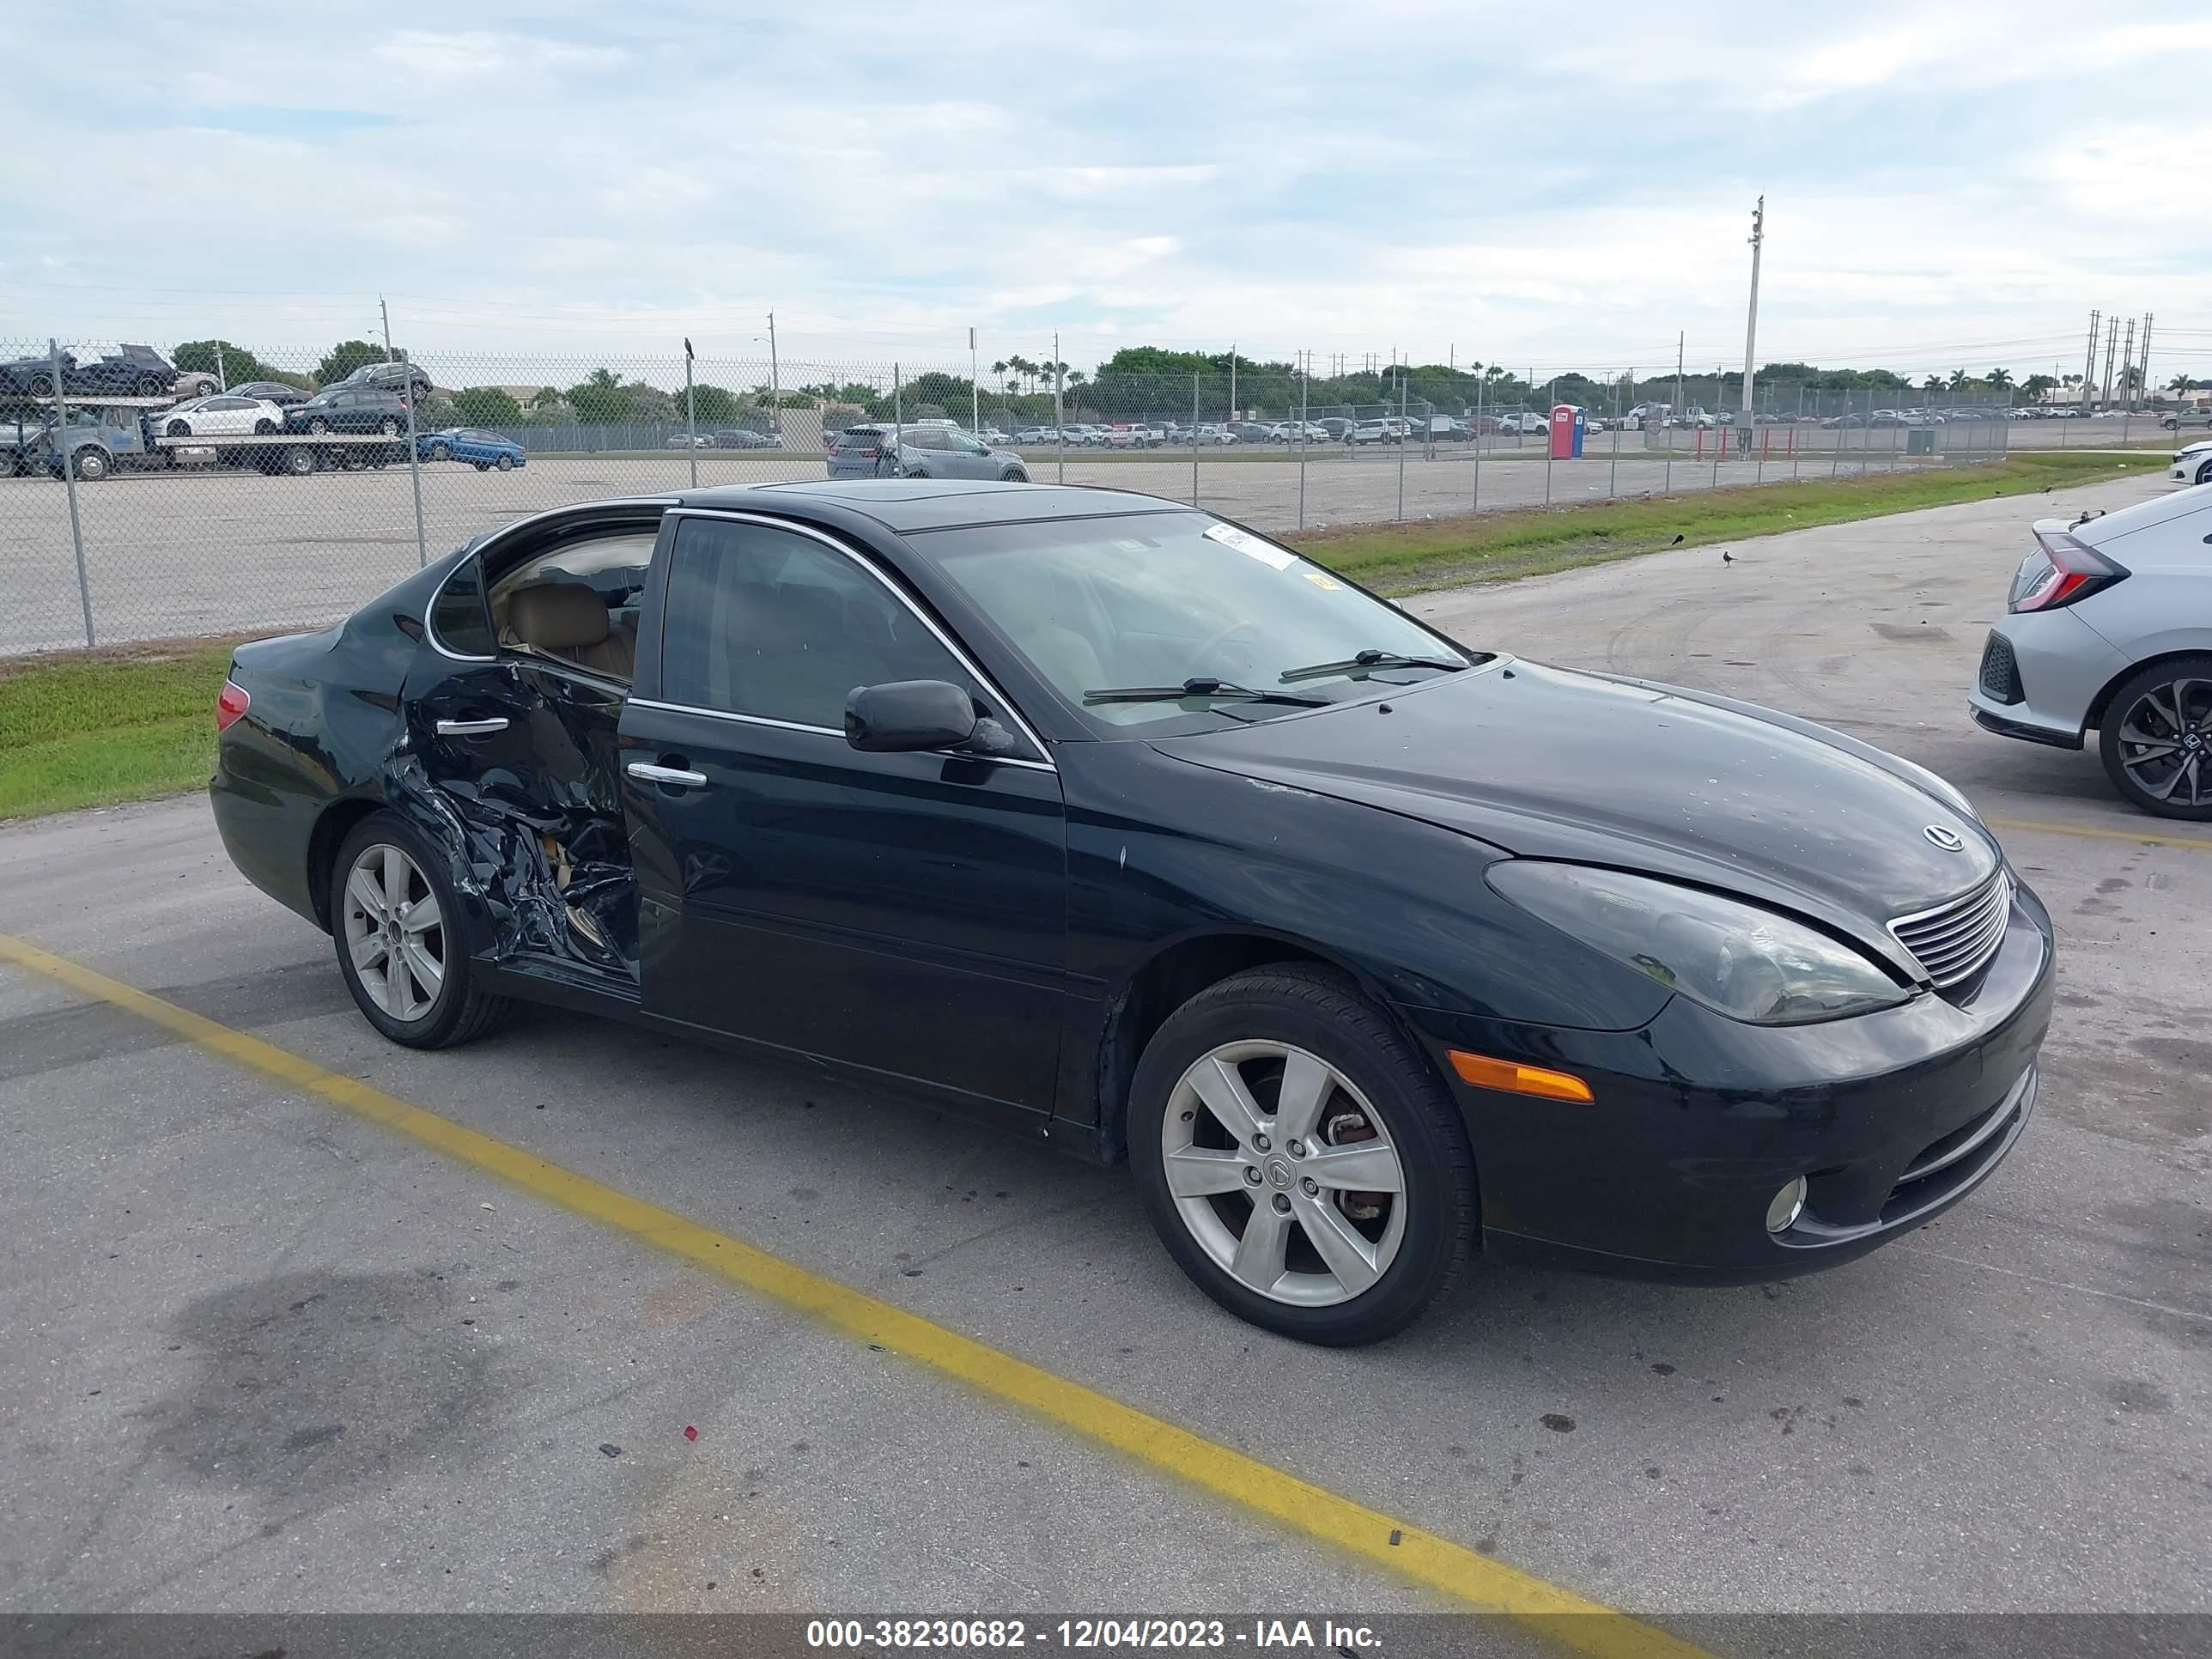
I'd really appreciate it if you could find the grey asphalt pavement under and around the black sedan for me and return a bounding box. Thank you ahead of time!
[0,465,2212,1646]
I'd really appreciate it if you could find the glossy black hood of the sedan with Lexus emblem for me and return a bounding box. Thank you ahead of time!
[1152,657,2002,971]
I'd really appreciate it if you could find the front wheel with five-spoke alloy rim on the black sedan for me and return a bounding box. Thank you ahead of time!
[1128,963,1475,1347]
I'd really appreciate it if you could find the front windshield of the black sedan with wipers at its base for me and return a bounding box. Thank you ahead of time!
[911,514,1482,734]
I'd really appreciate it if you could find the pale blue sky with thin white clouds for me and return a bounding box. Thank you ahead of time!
[0,0,2212,383]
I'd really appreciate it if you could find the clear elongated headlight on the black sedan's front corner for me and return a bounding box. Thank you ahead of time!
[1489,858,1911,1026]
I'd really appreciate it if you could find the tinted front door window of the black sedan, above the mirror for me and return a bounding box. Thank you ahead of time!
[661,518,980,732]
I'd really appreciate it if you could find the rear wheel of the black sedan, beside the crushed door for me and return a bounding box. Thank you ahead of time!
[330,811,508,1048]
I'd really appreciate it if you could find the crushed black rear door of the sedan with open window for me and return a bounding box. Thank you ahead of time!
[407,522,657,998]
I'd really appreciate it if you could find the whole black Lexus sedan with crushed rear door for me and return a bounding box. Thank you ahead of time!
[212,480,2053,1343]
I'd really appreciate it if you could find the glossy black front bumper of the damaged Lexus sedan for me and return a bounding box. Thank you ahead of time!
[1402,887,2053,1283]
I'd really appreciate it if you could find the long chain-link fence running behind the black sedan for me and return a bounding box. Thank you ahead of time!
[21,329,2159,657]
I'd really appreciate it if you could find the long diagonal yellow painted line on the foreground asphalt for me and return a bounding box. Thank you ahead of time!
[0,933,1704,1659]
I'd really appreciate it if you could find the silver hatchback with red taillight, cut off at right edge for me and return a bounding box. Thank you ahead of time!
[1969,489,2212,821]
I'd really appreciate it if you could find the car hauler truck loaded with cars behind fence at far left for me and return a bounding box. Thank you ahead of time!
[0,398,407,484]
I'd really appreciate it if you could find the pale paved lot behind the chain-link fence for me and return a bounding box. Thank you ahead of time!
[0,442,2017,654]
